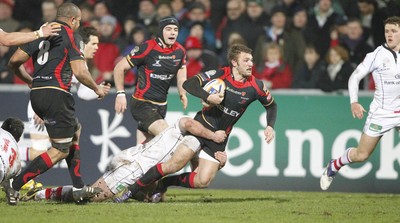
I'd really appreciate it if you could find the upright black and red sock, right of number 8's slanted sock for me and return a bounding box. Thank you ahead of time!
[65,145,84,188]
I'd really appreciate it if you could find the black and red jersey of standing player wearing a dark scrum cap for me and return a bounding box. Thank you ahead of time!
[126,38,186,104]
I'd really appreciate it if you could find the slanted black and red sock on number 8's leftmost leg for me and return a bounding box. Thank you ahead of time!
[12,153,54,190]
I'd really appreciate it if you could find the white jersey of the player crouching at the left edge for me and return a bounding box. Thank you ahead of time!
[0,128,21,183]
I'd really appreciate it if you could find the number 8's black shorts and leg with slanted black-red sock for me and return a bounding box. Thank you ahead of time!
[7,89,77,205]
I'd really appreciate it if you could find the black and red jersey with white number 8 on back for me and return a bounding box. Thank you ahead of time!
[21,21,84,92]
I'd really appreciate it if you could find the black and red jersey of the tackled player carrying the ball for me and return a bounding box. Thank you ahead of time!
[195,67,274,134]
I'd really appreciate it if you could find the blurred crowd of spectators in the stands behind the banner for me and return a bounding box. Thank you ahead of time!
[0,0,400,92]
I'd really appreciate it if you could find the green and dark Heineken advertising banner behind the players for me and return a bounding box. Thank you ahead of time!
[0,88,400,193]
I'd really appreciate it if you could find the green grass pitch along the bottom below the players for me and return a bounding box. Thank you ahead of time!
[0,189,400,223]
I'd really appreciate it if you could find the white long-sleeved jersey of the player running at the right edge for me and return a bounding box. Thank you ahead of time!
[349,44,400,111]
